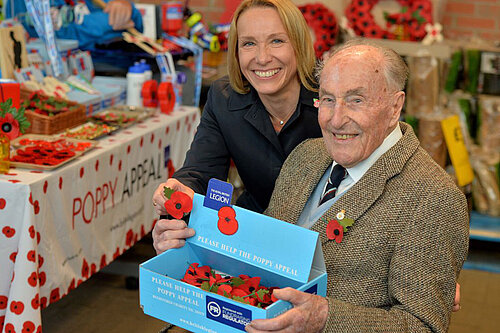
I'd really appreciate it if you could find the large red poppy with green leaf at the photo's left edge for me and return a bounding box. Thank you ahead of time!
[0,98,31,140]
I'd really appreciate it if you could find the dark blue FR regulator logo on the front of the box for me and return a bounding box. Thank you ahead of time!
[206,295,252,331]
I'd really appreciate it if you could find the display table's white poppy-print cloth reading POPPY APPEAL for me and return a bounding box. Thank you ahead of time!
[0,107,200,332]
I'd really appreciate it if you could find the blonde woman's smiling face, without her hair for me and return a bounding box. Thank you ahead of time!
[237,7,299,96]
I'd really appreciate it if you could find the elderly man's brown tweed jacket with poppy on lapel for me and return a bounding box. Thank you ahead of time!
[266,123,469,332]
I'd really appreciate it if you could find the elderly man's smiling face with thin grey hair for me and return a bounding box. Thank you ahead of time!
[318,46,404,168]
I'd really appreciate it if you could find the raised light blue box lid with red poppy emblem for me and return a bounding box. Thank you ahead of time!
[187,194,325,283]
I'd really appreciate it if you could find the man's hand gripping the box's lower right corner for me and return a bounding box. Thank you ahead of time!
[245,288,328,333]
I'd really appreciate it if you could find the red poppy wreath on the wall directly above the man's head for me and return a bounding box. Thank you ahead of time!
[345,0,432,41]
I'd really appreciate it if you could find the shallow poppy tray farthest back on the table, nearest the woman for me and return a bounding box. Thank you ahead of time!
[92,106,155,128]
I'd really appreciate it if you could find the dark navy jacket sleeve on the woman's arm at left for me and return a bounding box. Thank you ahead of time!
[172,82,230,194]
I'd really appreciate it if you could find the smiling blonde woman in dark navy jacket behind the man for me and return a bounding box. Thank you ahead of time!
[153,0,321,223]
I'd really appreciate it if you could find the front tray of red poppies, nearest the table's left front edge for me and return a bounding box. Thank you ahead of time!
[10,134,97,170]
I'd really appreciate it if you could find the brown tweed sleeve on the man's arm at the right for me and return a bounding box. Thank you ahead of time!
[324,185,469,333]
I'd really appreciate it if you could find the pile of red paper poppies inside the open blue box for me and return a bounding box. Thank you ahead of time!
[181,263,279,309]
